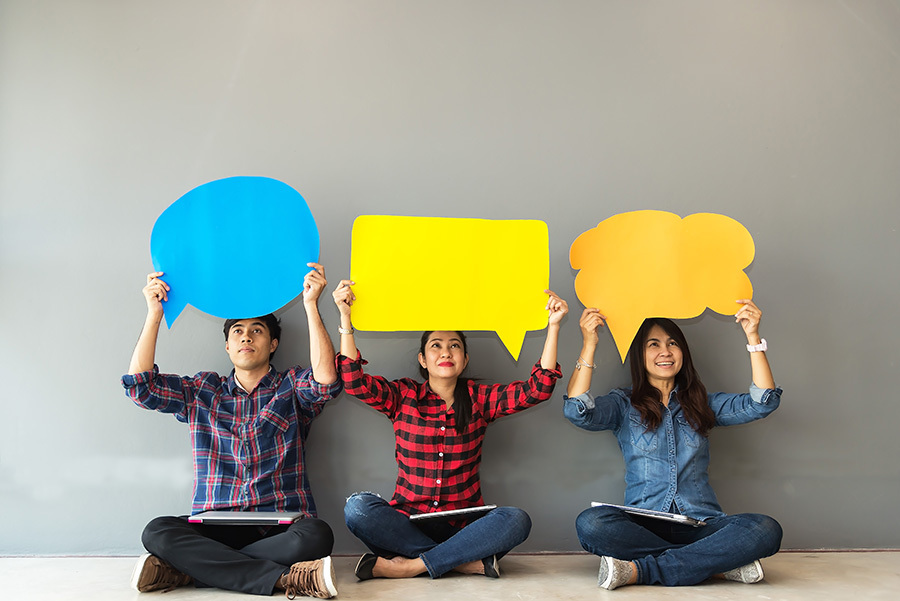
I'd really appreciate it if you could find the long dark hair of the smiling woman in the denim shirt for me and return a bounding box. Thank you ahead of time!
[628,317,716,436]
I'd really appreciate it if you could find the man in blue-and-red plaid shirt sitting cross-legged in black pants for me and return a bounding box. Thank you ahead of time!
[122,263,341,598]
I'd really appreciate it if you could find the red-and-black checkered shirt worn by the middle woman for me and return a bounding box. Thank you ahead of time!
[337,354,562,514]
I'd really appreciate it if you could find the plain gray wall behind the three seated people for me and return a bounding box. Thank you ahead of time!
[0,0,900,555]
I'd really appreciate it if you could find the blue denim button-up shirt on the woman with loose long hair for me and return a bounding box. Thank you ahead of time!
[563,383,781,520]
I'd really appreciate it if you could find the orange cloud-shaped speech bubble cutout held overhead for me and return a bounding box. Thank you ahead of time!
[569,211,755,363]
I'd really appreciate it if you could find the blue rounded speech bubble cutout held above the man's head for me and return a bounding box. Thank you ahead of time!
[150,177,319,328]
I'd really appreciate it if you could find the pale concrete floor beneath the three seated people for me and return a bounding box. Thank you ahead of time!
[0,552,900,601]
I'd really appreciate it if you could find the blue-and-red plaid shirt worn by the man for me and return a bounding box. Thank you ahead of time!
[122,365,341,517]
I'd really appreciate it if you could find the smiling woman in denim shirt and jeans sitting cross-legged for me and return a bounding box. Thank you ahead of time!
[564,299,782,590]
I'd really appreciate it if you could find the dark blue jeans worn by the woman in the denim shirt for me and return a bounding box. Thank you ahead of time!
[575,507,782,586]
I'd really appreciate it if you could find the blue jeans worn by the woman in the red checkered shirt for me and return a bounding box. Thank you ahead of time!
[344,493,531,578]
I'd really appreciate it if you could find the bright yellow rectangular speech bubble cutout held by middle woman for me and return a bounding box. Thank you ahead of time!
[350,215,550,361]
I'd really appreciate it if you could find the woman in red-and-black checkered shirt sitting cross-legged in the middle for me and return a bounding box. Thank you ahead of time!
[334,280,568,580]
